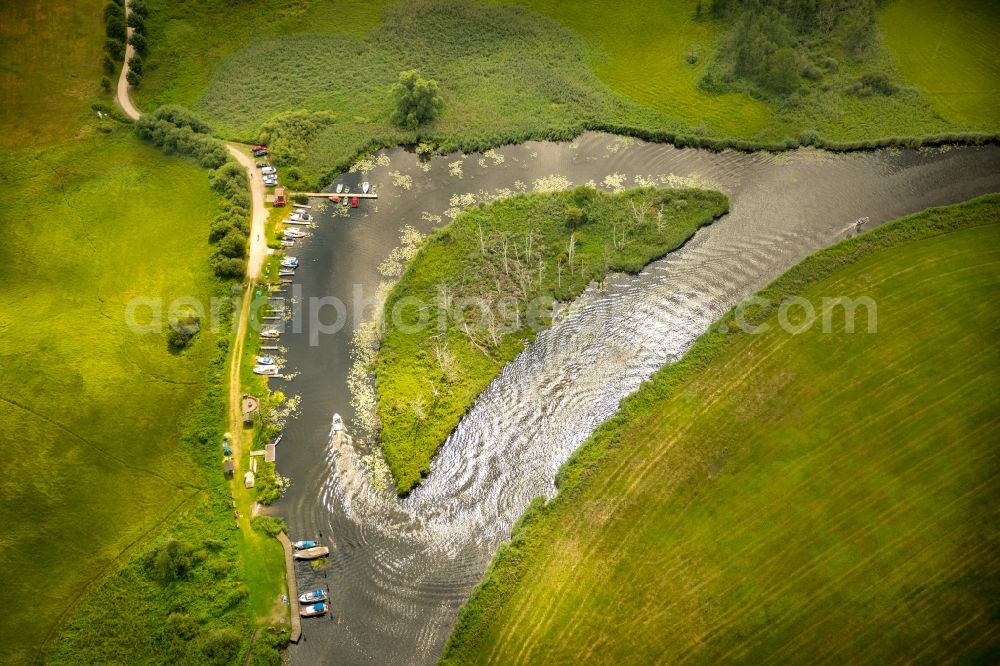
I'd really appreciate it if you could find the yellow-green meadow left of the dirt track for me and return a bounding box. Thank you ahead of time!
[0,0,278,664]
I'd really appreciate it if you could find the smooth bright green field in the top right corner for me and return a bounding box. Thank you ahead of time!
[880,0,1000,131]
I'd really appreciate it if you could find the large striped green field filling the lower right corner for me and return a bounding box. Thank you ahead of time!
[443,195,1000,664]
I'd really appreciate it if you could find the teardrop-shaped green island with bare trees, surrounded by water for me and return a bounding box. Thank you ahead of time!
[373,187,729,494]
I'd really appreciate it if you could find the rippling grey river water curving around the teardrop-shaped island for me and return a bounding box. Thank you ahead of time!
[272,133,1000,664]
